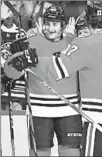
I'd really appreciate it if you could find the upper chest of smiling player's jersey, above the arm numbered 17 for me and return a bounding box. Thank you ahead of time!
[29,32,75,57]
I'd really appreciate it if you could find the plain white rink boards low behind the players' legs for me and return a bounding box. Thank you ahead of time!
[1,111,58,156]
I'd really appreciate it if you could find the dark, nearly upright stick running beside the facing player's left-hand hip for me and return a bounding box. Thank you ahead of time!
[25,72,37,157]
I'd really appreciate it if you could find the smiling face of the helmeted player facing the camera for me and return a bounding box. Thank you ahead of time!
[44,21,62,40]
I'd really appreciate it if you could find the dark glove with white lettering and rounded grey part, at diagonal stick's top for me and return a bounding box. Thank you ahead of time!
[4,49,38,80]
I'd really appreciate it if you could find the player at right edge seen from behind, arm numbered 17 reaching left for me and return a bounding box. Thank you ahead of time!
[4,2,102,156]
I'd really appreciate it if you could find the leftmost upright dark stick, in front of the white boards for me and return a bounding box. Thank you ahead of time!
[8,81,15,156]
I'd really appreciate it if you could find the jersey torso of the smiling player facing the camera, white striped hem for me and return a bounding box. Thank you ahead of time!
[25,33,79,117]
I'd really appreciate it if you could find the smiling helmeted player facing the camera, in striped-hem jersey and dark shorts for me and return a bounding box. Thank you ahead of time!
[5,6,82,156]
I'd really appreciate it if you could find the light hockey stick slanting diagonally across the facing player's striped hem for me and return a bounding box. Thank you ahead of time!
[25,69,102,133]
